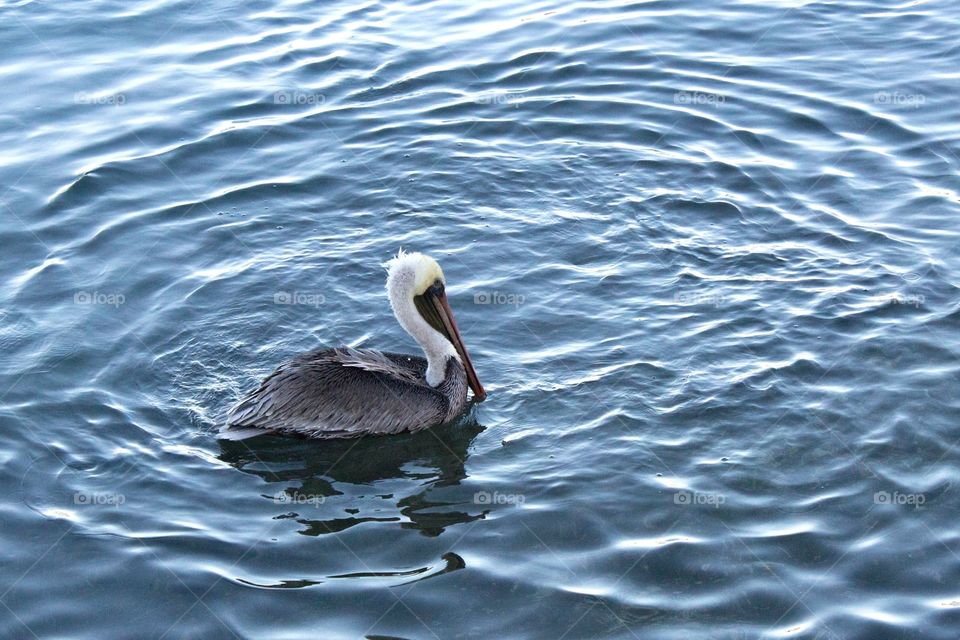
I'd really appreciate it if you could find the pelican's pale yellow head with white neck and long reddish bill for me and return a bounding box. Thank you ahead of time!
[386,250,487,400]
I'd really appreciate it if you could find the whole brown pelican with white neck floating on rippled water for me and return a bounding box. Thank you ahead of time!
[220,250,487,440]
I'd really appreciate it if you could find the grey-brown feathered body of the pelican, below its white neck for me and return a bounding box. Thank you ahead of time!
[221,348,449,439]
